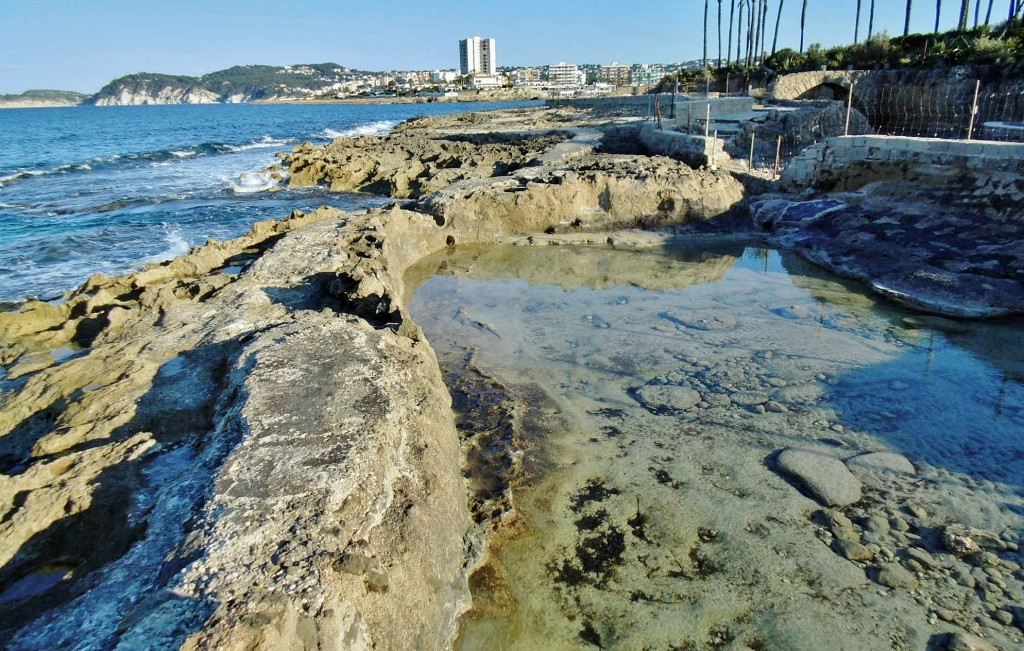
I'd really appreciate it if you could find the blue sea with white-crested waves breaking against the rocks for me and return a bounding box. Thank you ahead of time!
[0,102,537,304]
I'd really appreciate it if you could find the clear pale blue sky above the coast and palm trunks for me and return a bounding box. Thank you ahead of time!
[0,0,1008,93]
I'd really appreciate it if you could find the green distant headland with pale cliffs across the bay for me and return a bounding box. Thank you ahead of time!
[86,63,353,106]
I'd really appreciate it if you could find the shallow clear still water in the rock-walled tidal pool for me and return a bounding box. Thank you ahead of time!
[411,243,1024,649]
